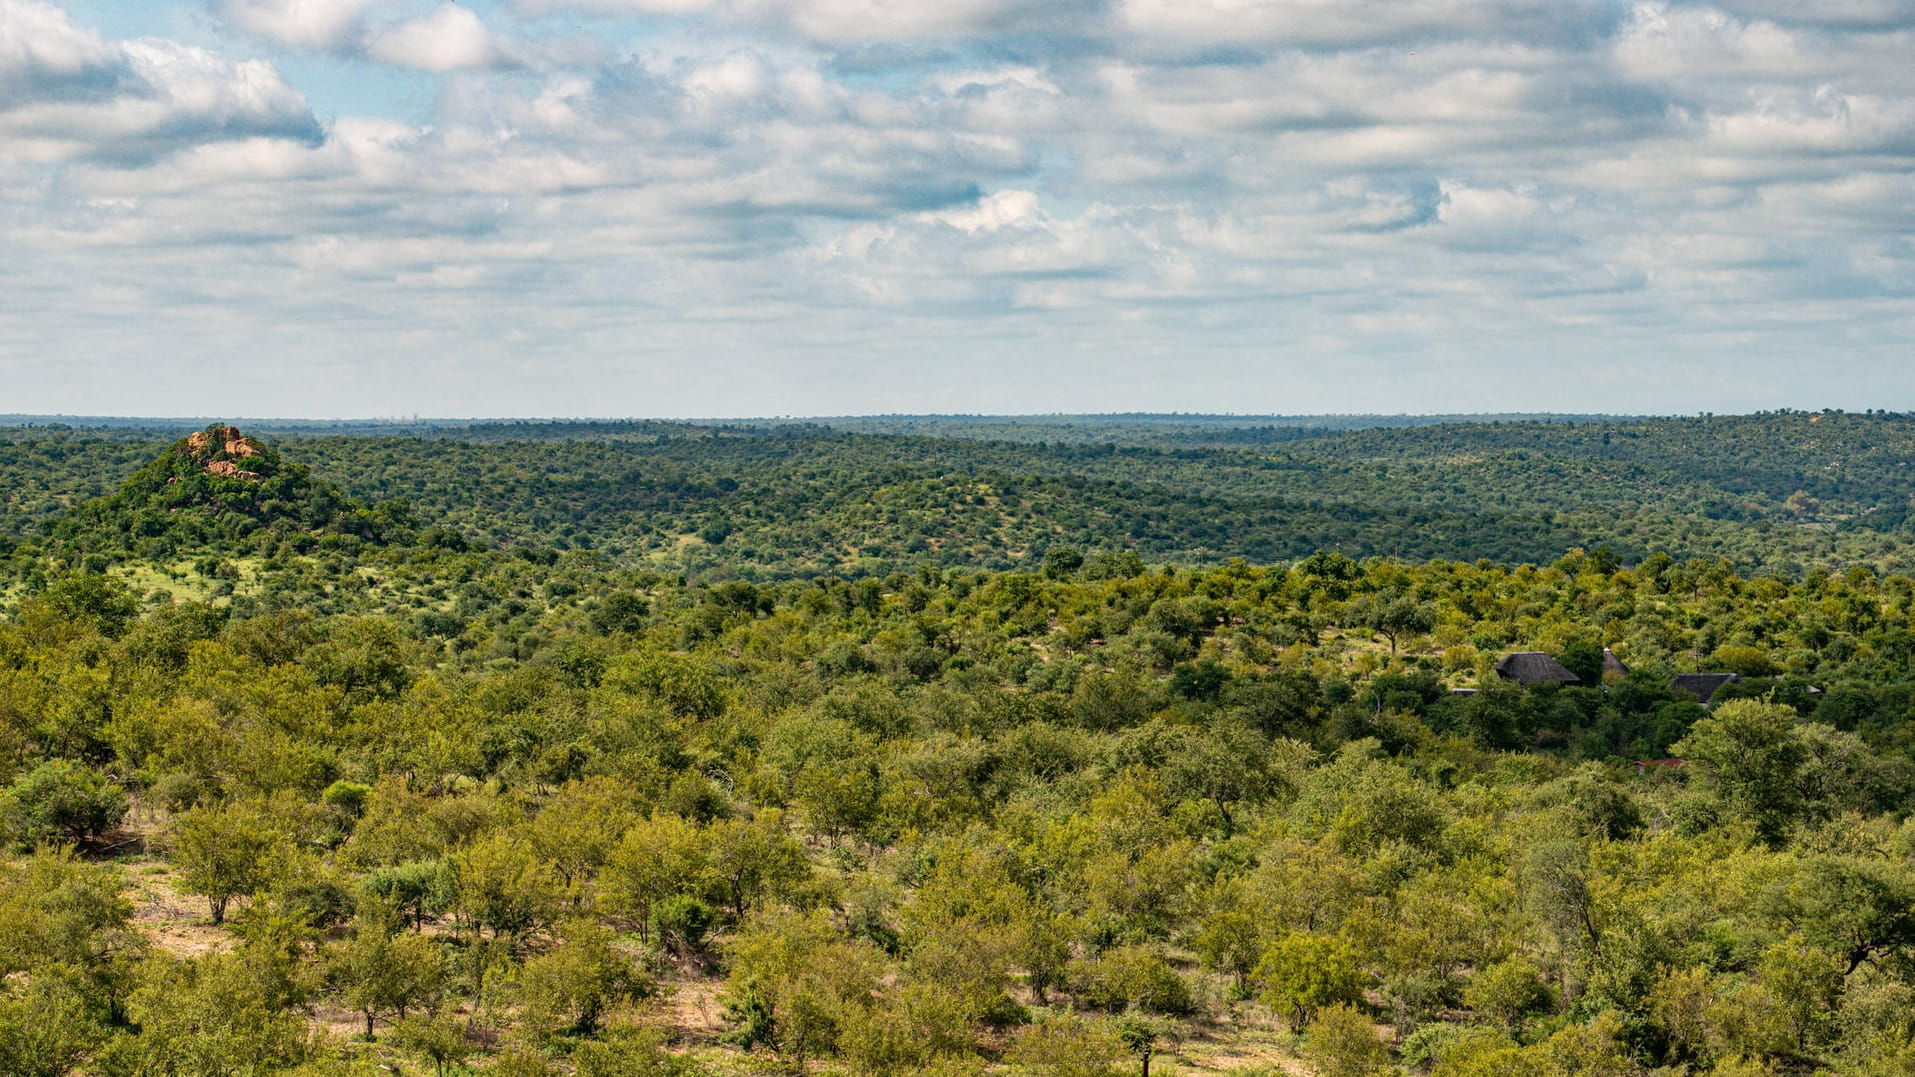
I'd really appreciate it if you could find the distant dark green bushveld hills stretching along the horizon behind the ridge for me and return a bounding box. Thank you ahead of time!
[11,412,1915,582]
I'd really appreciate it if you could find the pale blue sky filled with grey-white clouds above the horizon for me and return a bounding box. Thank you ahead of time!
[0,0,1915,418]
